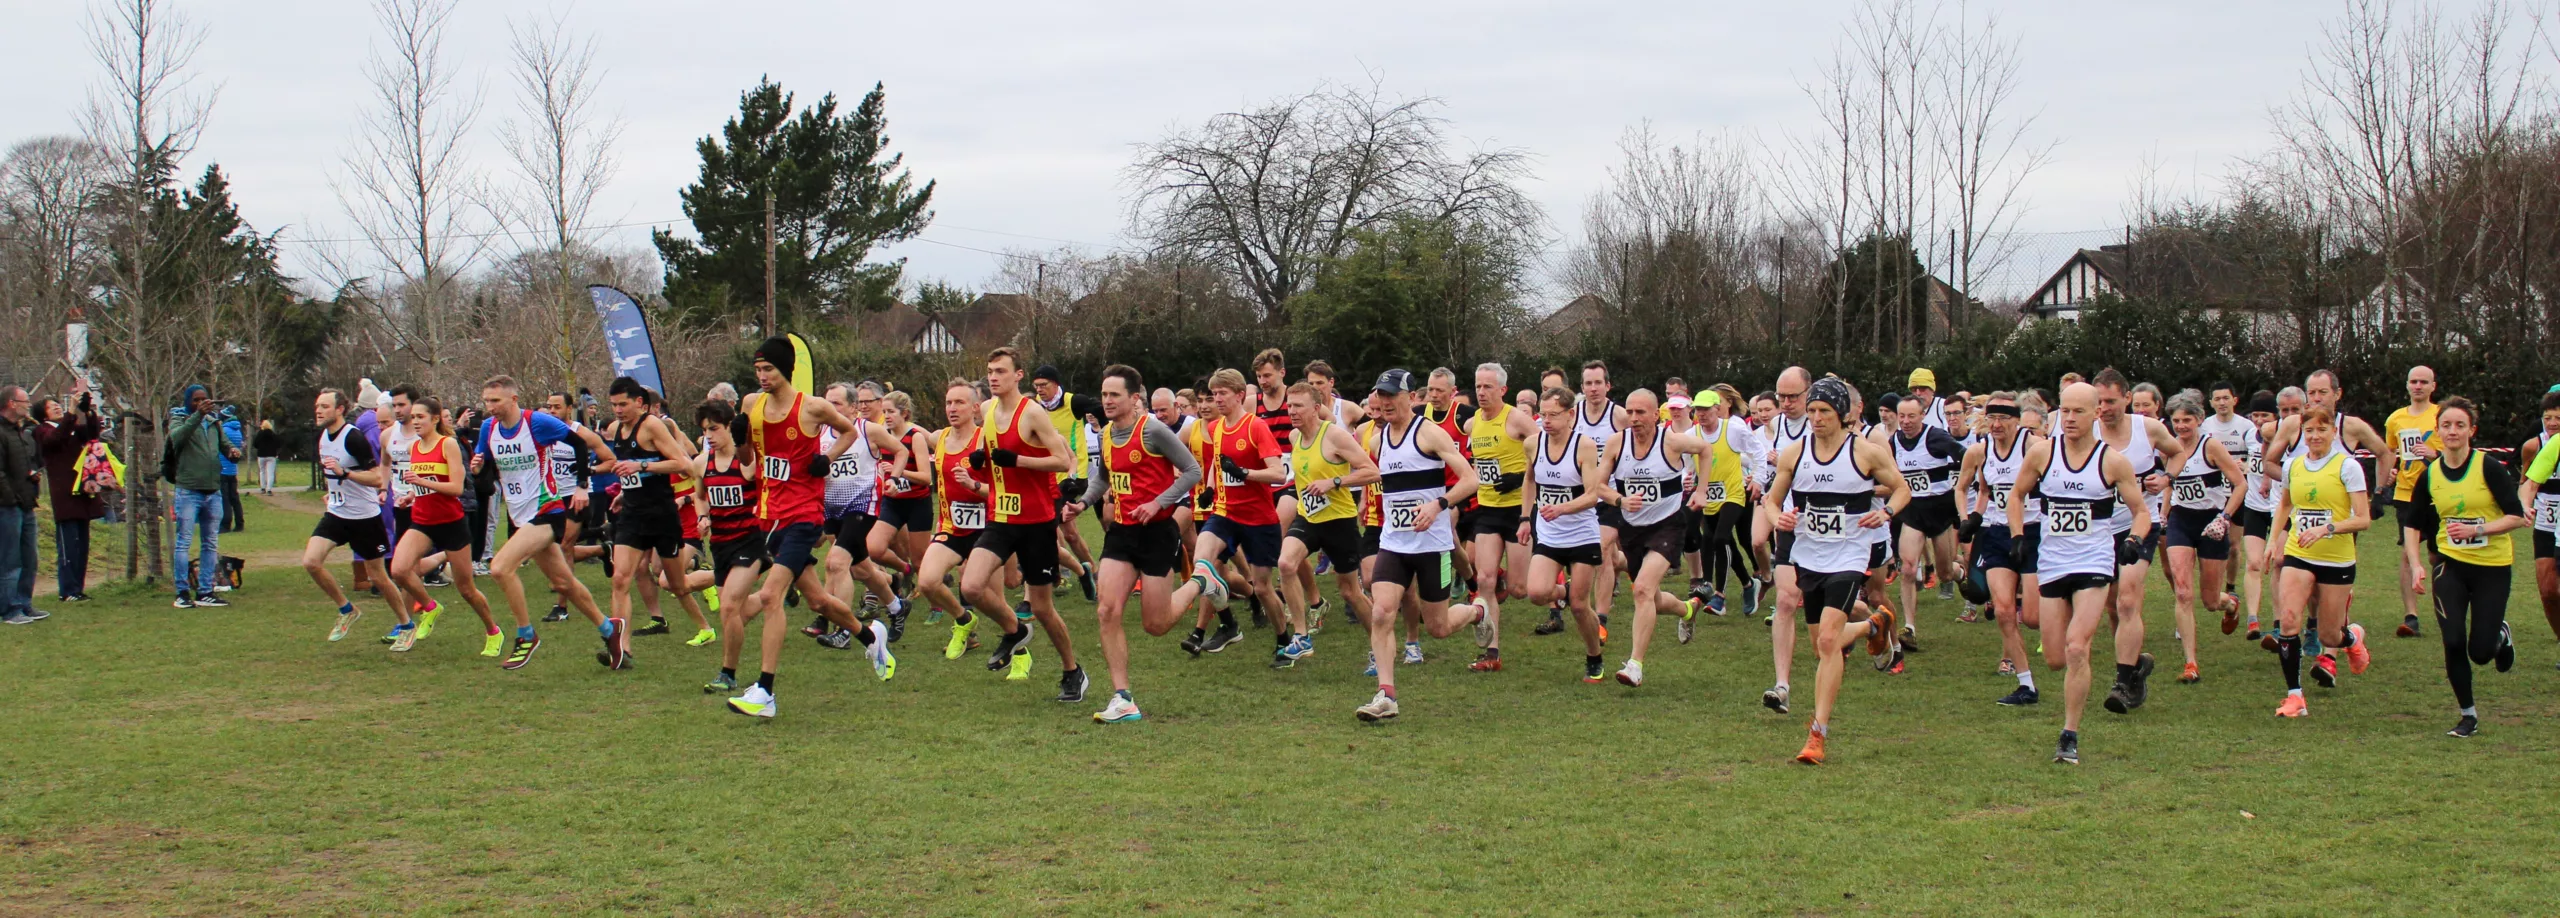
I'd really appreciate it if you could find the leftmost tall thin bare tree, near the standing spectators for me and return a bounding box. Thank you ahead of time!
[84,0,212,580]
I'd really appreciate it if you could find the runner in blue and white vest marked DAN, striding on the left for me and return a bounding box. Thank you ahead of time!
[471,376,622,670]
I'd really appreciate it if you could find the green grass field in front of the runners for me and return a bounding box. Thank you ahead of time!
[0,485,2560,915]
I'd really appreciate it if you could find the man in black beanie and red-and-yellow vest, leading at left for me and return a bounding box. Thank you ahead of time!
[730,338,896,716]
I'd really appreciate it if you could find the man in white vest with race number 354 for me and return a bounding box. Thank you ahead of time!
[1771,378,1910,765]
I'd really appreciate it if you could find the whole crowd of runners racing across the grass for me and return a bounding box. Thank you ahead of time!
[305,338,2560,765]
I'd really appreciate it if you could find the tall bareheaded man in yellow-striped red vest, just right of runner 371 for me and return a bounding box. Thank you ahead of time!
[960,348,1088,701]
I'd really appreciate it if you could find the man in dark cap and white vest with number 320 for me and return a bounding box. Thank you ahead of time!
[1352,368,1485,724]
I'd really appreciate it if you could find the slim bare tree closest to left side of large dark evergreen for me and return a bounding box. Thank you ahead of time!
[499,8,622,389]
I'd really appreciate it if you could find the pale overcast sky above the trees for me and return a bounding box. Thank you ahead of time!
[0,0,2375,306]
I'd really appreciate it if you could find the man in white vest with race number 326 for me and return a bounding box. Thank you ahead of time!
[2010,383,2150,765]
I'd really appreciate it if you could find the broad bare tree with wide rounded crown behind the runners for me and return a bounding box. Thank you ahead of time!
[1129,82,1536,325]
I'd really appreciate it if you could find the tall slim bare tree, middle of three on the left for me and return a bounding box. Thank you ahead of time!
[325,0,486,391]
